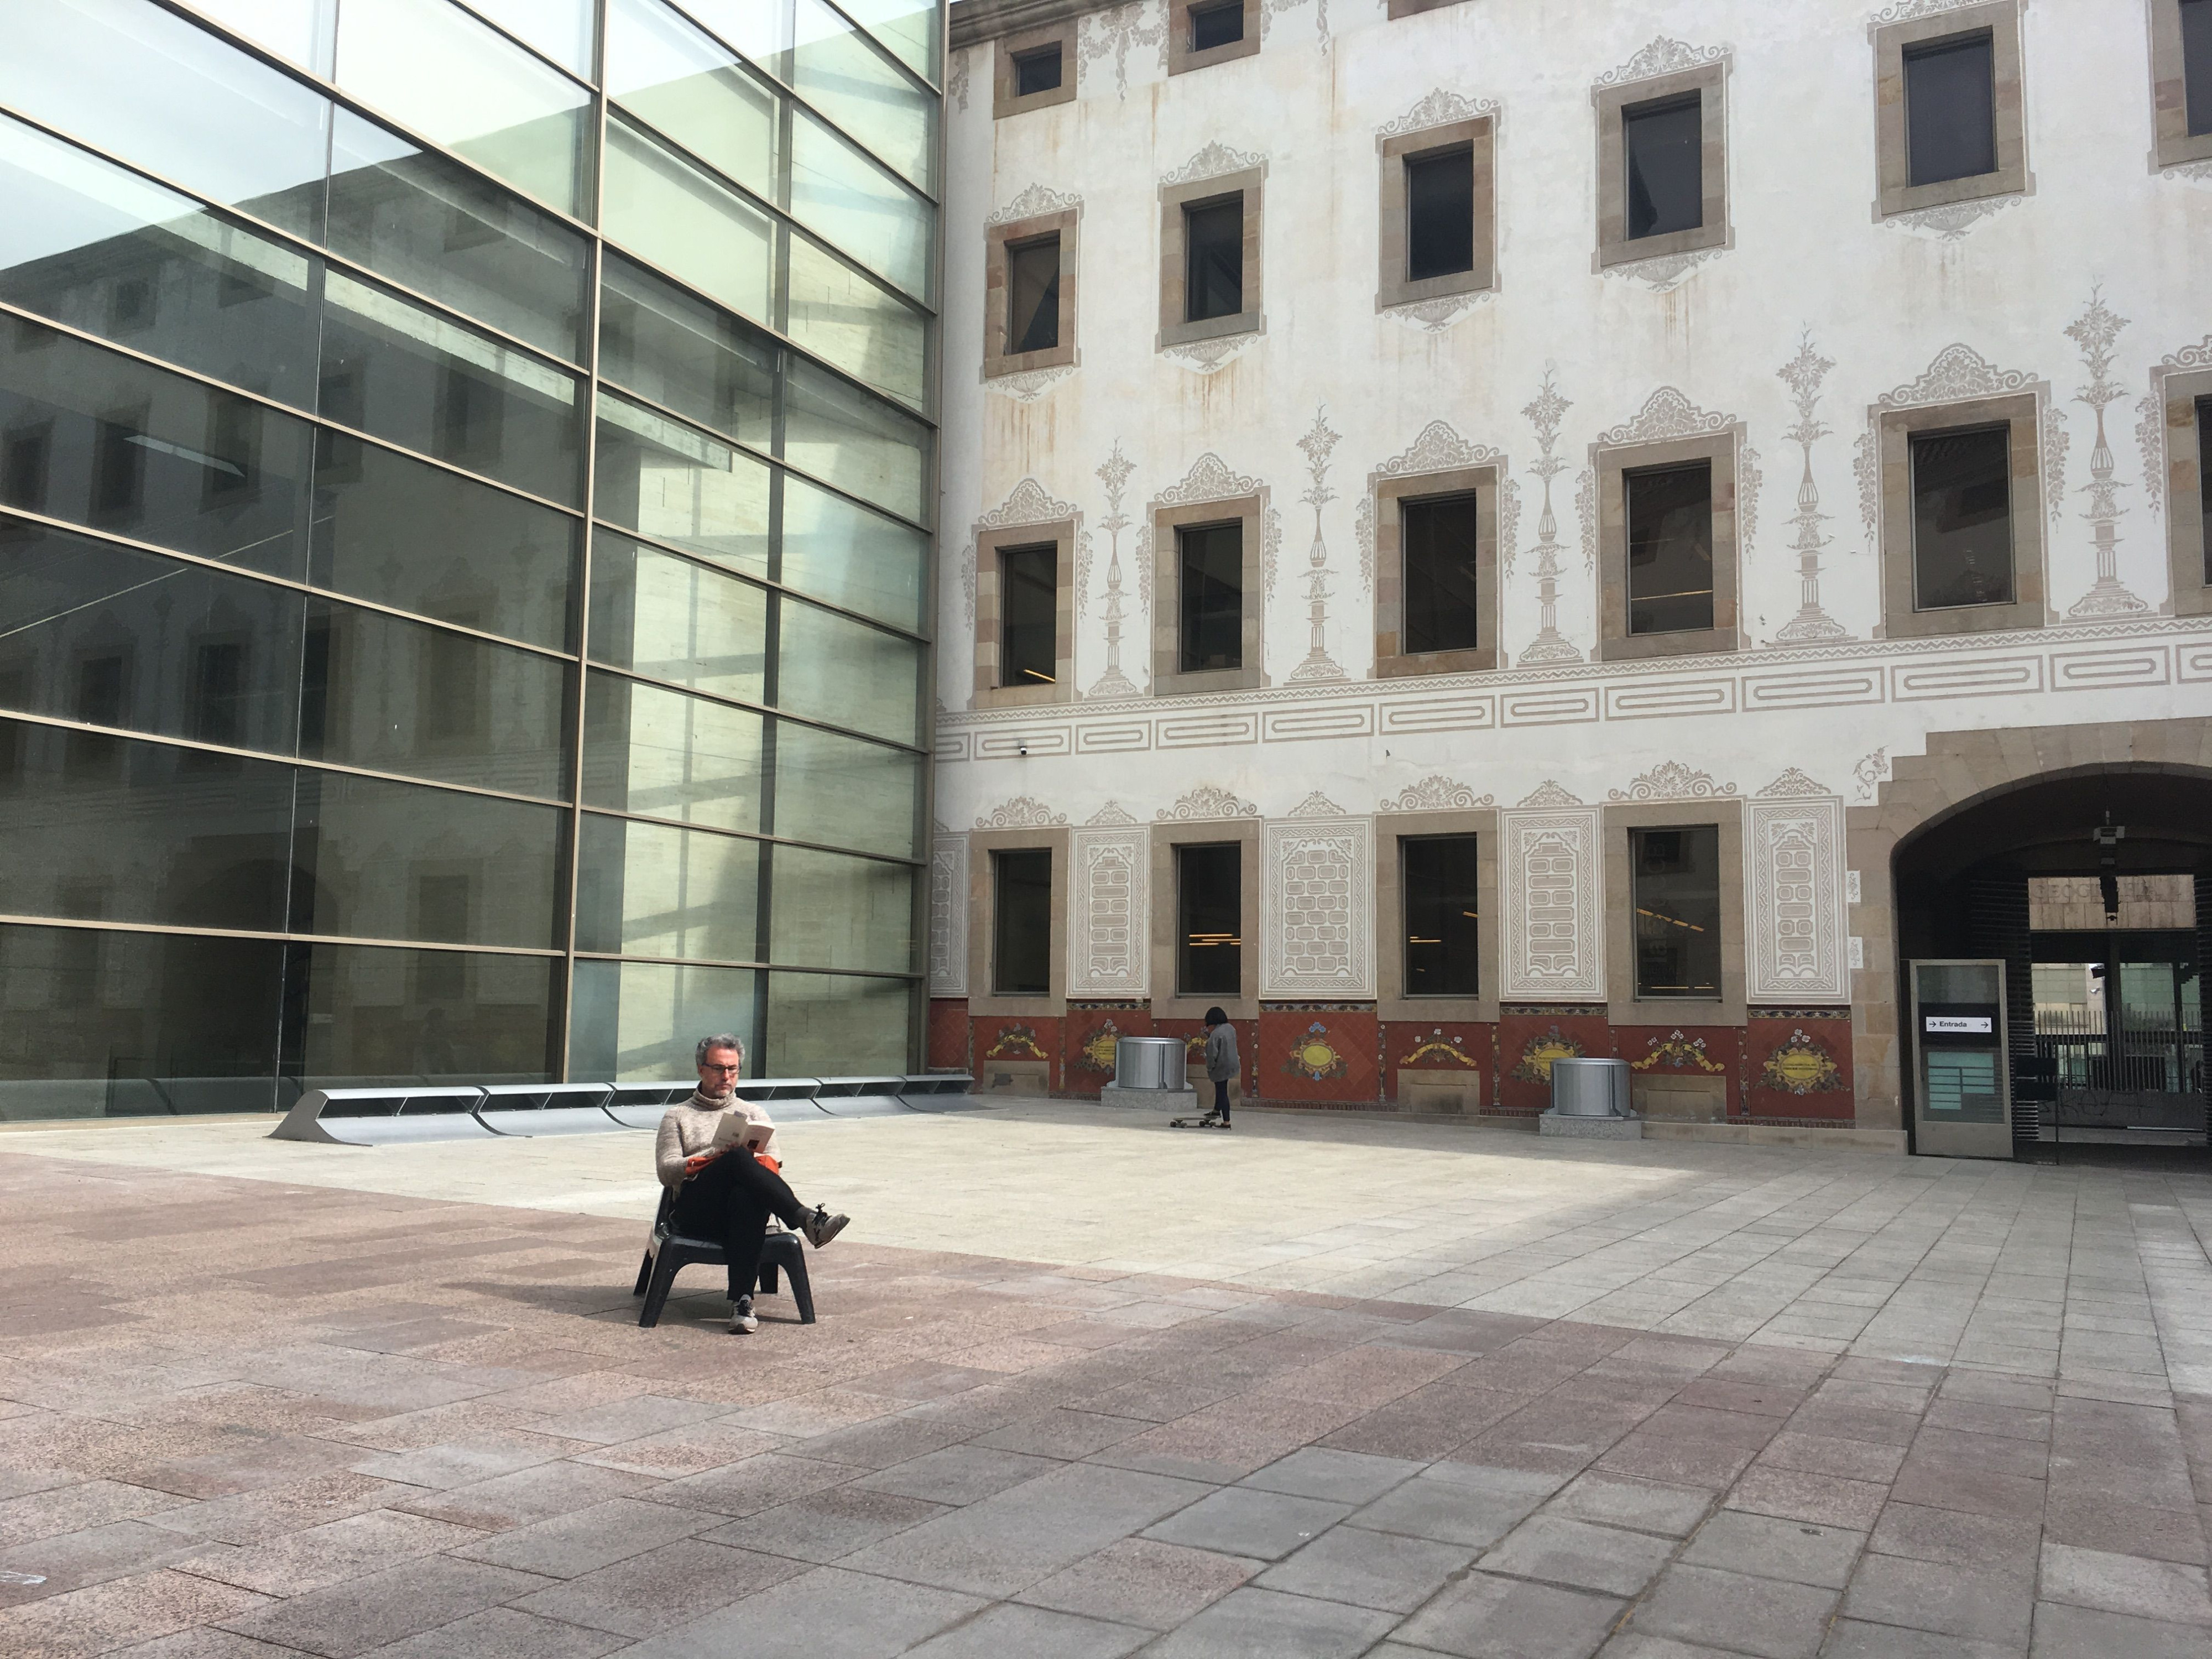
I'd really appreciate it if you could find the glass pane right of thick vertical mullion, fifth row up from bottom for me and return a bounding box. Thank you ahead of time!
[593,394,770,575]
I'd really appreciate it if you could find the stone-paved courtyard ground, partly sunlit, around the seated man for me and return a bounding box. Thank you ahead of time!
[0,1102,2212,1659]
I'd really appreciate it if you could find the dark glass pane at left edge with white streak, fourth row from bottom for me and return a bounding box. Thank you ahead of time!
[0,319,310,577]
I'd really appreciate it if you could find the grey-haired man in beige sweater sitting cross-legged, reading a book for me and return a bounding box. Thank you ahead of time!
[653,1033,849,1334]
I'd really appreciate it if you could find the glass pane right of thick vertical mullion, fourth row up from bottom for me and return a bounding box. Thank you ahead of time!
[591,531,768,703]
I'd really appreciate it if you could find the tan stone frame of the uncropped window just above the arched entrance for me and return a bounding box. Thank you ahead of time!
[1876,392,2051,639]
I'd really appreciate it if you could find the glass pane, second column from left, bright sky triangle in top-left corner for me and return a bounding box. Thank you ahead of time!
[327,111,591,363]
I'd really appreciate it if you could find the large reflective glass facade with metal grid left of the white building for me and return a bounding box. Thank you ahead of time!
[0,0,945,1117]
